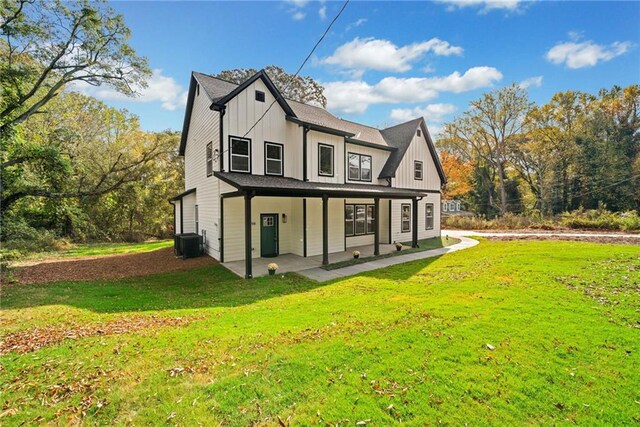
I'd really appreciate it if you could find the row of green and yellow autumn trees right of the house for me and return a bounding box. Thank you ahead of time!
[438,85,640,218]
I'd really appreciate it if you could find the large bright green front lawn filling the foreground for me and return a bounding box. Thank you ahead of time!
[0,241,640,426]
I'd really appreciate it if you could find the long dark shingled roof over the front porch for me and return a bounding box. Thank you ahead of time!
[214,172,437,199]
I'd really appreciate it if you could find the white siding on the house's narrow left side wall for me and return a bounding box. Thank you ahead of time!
[183,82,220,259]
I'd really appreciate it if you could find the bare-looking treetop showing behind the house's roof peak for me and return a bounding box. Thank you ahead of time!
[215,65,327,107]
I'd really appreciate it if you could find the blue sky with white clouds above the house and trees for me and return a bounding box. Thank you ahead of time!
[81,0,640,132]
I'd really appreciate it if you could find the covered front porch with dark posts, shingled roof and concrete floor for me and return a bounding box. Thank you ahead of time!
[215,172,431,279]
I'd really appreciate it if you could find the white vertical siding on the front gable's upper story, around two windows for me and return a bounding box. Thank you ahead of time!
[223,79,302,179]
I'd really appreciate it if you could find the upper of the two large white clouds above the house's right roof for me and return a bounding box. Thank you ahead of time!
[322,37,463,72]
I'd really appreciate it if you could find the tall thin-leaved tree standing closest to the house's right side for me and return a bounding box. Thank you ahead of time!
[443,84,532,215]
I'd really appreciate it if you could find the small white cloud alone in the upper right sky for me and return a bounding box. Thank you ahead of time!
[545,36,633,69]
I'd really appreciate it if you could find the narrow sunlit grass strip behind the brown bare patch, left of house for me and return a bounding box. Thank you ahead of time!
[21,240,173,259]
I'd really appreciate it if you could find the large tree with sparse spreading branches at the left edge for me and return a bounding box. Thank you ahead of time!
[0,0,155,214]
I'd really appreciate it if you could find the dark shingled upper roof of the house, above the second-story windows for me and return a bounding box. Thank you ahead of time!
[180,71,446,183]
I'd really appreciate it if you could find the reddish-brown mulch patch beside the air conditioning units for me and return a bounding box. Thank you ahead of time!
[13,248,216,284]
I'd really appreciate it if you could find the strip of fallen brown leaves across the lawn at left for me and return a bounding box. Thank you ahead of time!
[0,316,198,355]
